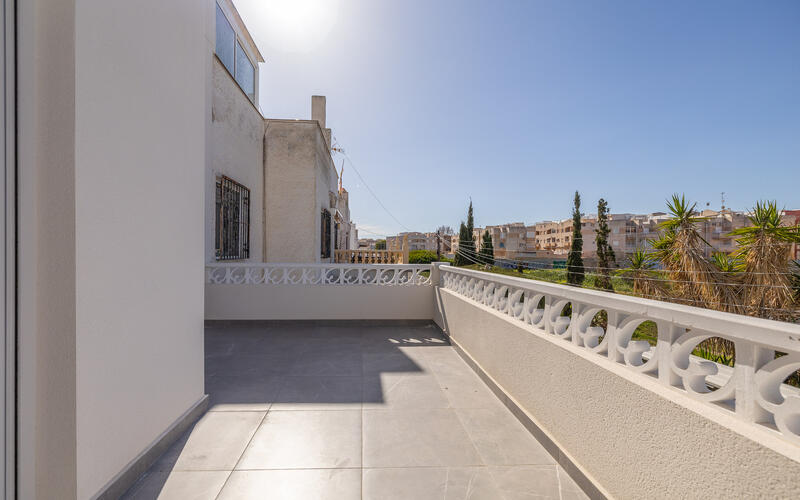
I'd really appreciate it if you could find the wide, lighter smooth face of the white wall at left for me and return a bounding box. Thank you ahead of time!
[72,0,210,498]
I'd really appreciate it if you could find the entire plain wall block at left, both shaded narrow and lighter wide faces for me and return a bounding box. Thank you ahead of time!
[19,0,209,498]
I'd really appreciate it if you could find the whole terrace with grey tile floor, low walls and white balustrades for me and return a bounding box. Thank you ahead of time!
[120,263,800,499]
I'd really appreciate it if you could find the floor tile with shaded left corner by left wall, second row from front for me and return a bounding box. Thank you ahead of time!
[155,411,264,471]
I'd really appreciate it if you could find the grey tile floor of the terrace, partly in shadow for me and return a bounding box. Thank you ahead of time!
[125,324,586,500]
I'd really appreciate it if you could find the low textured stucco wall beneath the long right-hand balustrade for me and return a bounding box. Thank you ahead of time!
[434,289,800,499]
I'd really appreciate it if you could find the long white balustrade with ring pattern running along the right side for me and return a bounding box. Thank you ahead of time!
[437,266,800,444]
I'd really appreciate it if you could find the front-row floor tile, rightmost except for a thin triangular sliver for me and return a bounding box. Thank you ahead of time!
[489,465,560,500]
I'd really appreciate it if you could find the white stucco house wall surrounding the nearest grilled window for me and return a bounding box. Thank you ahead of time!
[205,55,264,262]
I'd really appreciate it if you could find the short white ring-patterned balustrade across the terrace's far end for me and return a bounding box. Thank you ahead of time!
[206,263,431,286]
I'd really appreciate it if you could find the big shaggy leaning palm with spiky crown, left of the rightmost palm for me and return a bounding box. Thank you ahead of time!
[652,194,740,312]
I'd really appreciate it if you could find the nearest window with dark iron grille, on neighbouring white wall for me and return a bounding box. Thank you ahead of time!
[215,176,250,260]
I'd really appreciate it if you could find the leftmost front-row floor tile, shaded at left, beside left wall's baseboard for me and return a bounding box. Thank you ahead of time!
[122,471,230,500]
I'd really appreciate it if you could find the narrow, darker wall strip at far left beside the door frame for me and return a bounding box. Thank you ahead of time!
[17,0,76,498]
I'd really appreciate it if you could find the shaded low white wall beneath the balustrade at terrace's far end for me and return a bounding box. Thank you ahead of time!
[206,284,434,320]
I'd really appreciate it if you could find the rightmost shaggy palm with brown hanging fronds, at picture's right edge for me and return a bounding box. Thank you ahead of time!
[731,201,800,319]
